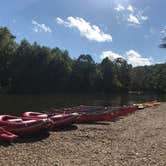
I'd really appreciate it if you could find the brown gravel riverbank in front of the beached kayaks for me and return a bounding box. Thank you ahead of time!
[0,103,166,166]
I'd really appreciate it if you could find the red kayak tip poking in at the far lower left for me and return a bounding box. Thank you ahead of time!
[0,127,18,141]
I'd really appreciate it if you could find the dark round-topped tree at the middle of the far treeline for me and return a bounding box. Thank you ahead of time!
[71,54,100,92]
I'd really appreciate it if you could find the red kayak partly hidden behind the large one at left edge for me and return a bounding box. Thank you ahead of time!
[23,112,79,127]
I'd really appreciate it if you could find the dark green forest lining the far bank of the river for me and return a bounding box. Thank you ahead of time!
[0,27,166,93]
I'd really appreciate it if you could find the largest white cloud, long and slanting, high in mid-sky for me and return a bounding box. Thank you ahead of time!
[56,17,112,42]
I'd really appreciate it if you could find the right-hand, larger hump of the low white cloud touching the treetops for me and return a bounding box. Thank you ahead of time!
[126,50,153,67]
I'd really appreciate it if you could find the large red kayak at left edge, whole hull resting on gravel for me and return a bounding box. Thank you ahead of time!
[0,115,51,136]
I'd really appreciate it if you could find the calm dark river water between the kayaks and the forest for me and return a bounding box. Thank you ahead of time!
[0,94,166,115]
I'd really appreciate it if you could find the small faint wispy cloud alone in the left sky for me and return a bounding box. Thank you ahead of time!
[32,20,52,33]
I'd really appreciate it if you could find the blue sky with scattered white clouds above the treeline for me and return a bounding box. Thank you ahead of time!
[0,0,166,66]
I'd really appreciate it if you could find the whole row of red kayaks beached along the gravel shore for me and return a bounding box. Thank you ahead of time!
[0,103,159,141]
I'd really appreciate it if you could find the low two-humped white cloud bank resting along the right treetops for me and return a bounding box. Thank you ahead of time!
[100,50,153,67]
